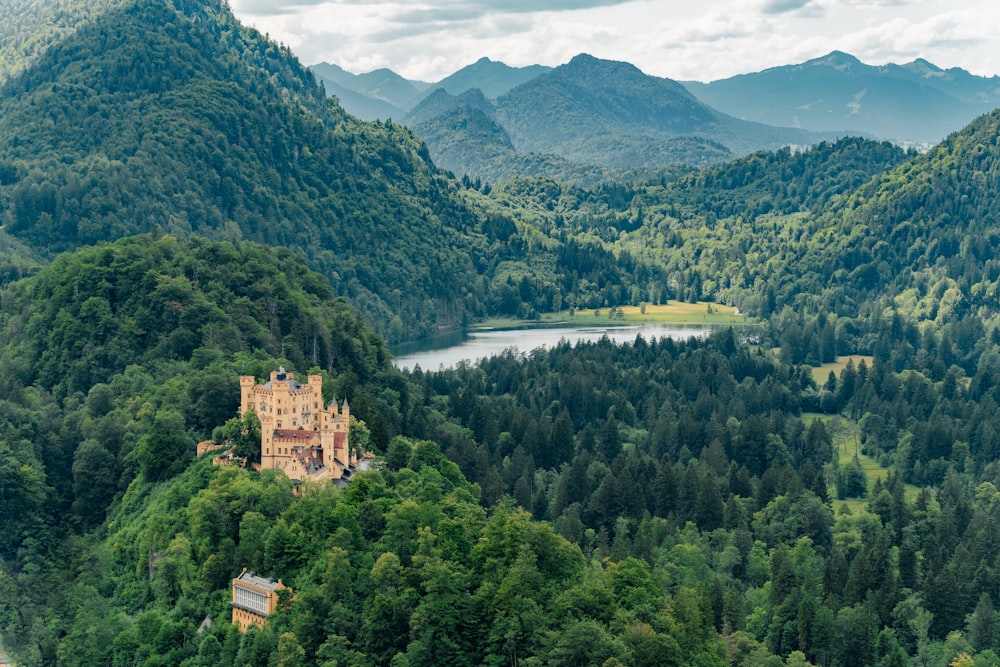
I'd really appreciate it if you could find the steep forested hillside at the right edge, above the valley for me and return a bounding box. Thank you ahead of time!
[814,110,1000,321]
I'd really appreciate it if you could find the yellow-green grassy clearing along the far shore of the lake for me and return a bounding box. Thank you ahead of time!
[479,301,755,329]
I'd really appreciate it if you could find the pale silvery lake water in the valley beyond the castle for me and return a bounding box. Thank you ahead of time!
[392,324,711,371]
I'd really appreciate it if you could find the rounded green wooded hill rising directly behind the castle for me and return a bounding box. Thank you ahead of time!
[0,236,400,544]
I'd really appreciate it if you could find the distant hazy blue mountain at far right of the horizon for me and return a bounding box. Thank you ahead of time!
[685,51,1000,144]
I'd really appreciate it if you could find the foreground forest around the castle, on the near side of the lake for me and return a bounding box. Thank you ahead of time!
[0,236,1000,665]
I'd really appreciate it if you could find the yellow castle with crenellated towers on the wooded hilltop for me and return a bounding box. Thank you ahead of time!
[240,368,358,482]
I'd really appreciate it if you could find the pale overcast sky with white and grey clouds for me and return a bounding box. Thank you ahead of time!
[230,0,1000,82]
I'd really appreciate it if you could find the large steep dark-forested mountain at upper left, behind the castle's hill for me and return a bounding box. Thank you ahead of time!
[0,0,496,339]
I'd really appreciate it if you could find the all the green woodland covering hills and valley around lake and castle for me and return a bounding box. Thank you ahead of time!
[0,0,1000,667]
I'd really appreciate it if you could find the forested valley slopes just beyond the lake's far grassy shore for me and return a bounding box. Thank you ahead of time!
[458,139,915,320]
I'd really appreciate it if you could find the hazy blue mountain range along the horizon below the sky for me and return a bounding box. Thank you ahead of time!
[312,52,1000,183]
